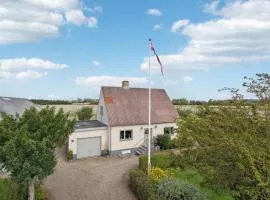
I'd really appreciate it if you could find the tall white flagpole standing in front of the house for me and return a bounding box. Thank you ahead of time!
[147,39,151,175]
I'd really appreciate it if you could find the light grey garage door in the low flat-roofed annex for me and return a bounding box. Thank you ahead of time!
[77,137,101,158]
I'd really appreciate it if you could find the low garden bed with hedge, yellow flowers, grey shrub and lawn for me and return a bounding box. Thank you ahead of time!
[129,151,233,200]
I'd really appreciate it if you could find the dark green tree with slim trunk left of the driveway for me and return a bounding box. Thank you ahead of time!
[0,107,75,200]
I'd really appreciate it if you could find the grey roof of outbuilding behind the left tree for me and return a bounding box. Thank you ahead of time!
[0,97,34,116]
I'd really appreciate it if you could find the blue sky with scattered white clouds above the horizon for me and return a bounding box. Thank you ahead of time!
[0,0,270,100]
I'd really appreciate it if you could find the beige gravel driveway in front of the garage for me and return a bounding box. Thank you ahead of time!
[45,148,138,200]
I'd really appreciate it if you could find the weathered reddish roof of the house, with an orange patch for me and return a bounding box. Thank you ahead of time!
[101,87,178,126]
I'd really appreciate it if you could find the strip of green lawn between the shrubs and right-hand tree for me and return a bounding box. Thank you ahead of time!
[166,168,233,200]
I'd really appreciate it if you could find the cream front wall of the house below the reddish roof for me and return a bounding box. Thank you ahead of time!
[111,123,177,151]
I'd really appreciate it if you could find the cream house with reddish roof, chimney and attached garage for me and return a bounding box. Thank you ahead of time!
[69,81,178,159]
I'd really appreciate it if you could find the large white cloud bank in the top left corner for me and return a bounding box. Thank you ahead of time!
[0,0,97,44]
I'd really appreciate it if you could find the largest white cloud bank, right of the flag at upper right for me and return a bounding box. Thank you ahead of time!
[141,0,270,71]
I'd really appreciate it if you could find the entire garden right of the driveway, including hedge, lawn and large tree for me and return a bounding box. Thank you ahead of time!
[129,74,270,200]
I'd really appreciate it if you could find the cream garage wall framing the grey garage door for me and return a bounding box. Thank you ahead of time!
[68,127,108,154]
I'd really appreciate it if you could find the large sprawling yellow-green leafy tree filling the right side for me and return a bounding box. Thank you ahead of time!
[176,74,270,200]
